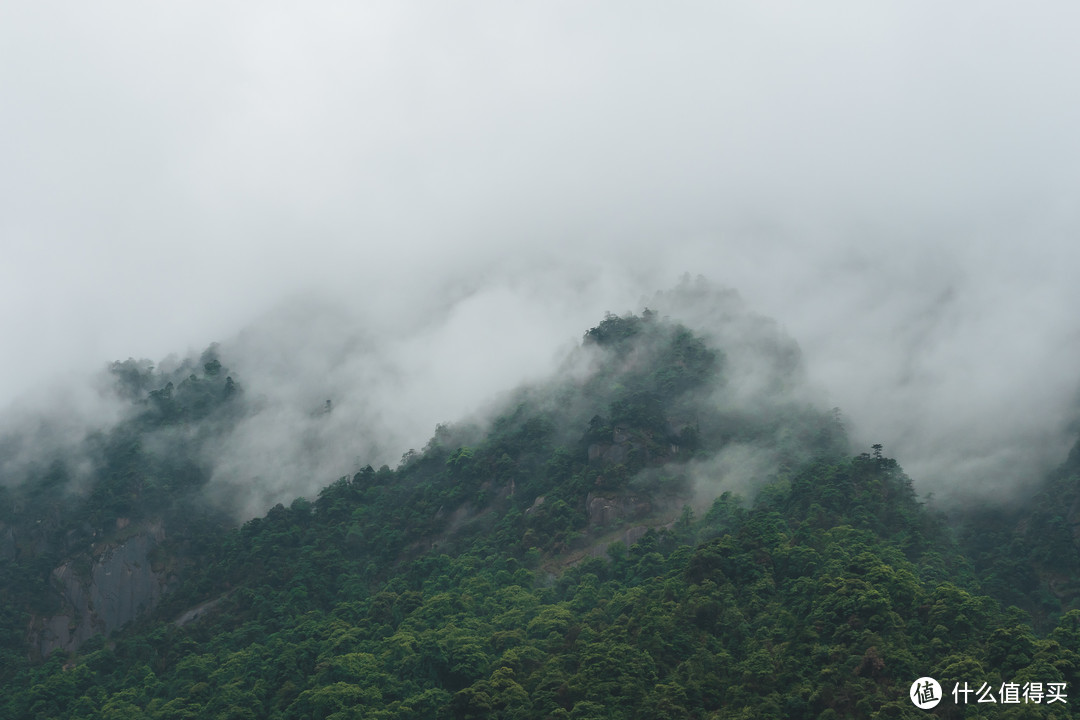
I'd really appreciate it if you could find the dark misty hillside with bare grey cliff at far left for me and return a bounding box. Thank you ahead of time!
[0,348,242,657]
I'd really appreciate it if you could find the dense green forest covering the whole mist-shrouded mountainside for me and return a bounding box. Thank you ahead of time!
[0,302,1080,720]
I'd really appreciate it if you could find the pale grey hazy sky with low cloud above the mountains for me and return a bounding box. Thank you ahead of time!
[0,0,1080,505]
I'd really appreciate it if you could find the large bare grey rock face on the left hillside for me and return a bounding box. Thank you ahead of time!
[30,525,172,657]
